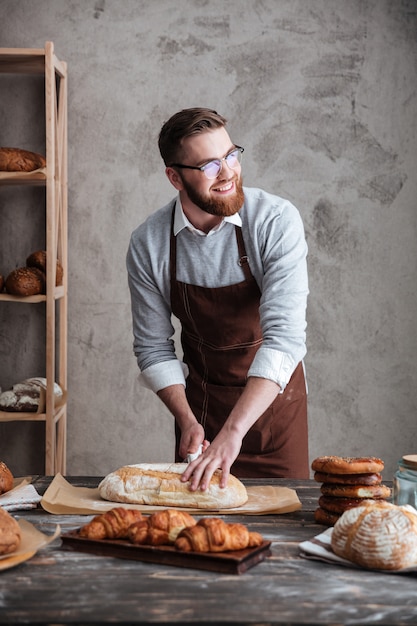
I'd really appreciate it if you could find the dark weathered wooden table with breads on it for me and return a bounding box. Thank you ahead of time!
[0,477,417,626]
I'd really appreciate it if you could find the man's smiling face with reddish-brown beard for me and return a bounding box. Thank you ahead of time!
[169,128,244,217]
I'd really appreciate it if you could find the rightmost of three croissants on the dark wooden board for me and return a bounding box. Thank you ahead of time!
[175,517,263,552]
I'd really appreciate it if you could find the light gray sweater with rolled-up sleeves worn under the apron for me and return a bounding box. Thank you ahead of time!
[126,187,308,391]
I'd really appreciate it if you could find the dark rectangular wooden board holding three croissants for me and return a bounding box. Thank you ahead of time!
[61,530,271,574]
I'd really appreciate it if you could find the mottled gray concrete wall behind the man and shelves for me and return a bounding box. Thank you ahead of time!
[0,0,417,479]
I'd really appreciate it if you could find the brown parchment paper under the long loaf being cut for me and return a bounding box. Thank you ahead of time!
[41,474,301,515]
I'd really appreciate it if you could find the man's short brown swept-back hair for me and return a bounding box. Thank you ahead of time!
[158,107,227,166]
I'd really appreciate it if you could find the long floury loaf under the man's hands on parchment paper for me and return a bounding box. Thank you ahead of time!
[98,463,248,510]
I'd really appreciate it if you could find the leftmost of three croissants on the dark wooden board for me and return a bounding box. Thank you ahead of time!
[79,507,143,539]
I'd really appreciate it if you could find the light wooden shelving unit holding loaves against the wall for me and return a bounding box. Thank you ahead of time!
[0,42,68,475]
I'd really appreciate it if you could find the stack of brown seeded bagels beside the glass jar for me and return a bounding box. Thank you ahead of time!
[311,456,391,526]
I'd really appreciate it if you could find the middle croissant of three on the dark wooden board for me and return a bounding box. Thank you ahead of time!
[128,509,197,546]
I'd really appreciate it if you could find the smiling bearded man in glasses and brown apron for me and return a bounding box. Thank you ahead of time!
[127,108,309,490]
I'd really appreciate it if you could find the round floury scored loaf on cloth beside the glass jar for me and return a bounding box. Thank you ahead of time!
[331,500,417,570]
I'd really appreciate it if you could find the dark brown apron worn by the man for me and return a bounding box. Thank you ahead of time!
[170,210,309,478]
